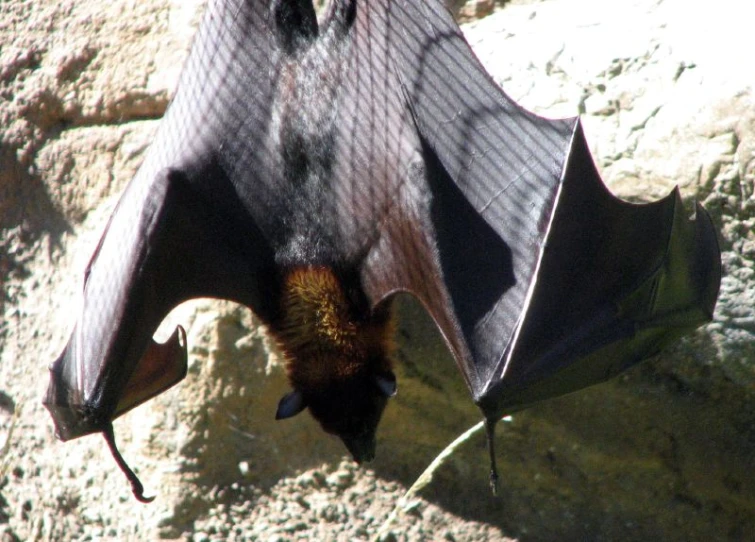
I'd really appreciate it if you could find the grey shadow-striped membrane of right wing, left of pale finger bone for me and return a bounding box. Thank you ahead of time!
[360,1,576,397]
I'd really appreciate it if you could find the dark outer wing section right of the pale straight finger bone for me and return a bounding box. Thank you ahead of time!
[481,127,721,413]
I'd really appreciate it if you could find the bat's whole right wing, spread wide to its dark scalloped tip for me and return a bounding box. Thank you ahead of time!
[351,0,721,420]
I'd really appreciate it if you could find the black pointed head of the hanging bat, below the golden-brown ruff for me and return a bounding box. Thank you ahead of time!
[275,371,396,463]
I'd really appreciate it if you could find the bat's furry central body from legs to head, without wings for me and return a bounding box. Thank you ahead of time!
[261,2,393,460]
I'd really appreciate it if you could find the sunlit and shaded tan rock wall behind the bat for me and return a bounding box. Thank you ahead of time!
[0,0,755,541]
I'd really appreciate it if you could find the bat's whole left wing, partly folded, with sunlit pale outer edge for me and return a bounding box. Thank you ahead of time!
[44,1,273,440]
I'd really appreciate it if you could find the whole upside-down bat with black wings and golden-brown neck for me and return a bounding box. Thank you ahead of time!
[45,0,721,499]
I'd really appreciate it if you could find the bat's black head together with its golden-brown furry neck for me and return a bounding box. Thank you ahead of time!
[273,266,396,463]
